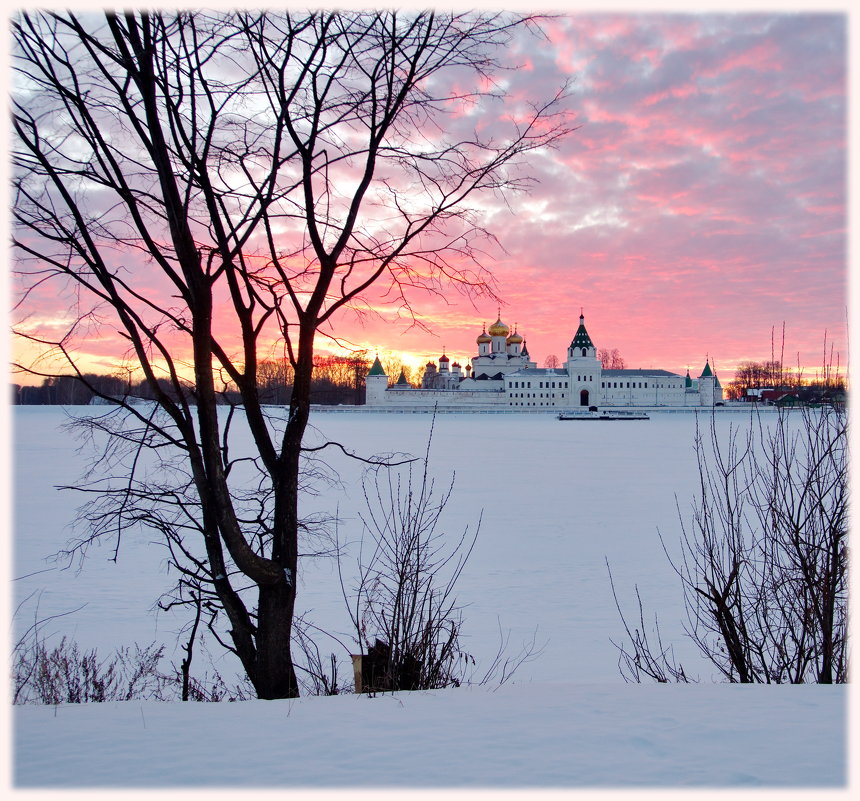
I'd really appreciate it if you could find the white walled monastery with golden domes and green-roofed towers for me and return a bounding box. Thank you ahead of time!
[365,315,723,409]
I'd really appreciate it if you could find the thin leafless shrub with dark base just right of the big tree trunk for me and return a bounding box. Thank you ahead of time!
[338,419,480,692]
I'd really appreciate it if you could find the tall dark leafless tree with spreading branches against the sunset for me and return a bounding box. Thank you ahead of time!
[12,12,569,698]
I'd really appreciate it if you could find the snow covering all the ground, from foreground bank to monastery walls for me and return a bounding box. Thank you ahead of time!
[5,407,847,789]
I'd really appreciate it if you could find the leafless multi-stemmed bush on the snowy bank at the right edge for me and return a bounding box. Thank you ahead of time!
[619,407,848,684]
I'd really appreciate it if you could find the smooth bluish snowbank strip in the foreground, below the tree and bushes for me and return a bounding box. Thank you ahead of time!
[15,682,844,789]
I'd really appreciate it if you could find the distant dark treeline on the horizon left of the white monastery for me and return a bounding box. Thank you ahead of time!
[11,351,370,406]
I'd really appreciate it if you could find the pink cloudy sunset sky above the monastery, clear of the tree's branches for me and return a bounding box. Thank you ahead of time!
[15,14,848,381]
